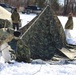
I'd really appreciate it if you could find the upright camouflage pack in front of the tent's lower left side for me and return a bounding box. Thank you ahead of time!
[16,40,30,62]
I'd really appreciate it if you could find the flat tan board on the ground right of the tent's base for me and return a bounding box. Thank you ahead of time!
[59,48,76,60]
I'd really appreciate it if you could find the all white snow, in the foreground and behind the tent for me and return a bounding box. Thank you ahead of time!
[0,14,76,75]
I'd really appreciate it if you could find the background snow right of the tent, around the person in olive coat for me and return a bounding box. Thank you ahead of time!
[58,16,76,45]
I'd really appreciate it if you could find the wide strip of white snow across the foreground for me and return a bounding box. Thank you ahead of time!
[0,62,76,75]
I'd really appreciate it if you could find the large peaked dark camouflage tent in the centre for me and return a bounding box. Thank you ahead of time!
[22,5,66,59]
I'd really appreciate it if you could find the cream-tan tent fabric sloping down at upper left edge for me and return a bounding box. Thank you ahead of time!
[0,6,11,21]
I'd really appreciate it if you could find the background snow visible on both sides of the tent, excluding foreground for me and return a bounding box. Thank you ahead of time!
[20,13,76,45]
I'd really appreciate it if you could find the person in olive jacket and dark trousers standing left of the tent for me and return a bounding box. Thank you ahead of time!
[11,8,20,30]
